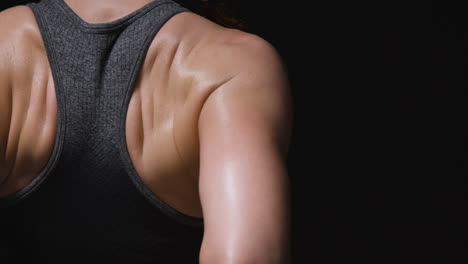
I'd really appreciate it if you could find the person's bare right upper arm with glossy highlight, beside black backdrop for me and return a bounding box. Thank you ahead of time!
[199,36,292,264]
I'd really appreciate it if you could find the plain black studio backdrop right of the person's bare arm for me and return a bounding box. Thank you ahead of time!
[0,1,467,263]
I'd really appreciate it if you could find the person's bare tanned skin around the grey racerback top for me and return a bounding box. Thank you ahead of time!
[0,0,293,264]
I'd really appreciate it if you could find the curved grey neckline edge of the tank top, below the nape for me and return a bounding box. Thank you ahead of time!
[49,0,172,33]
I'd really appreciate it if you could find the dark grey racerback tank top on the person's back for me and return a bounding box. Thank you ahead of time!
[0,0,204,264]
